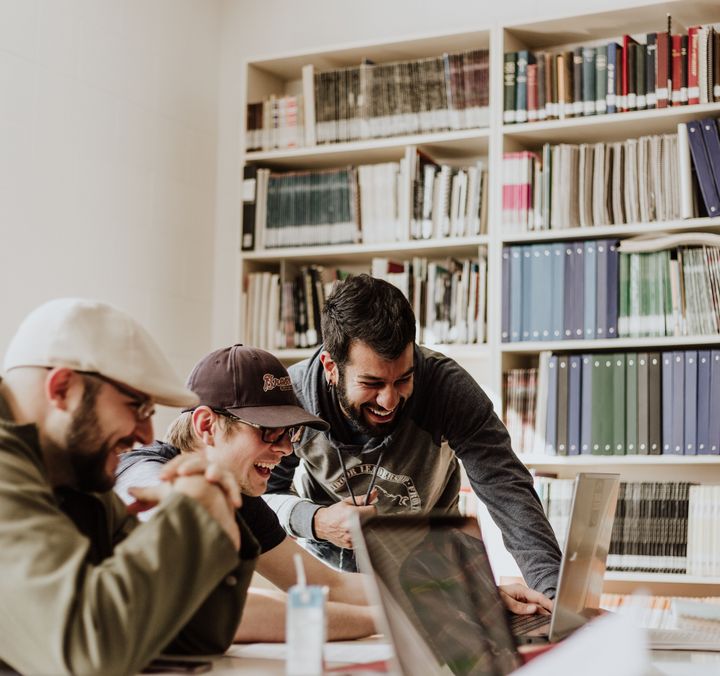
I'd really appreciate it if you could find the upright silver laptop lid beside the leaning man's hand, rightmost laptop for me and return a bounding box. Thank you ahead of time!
[550,472,620,641]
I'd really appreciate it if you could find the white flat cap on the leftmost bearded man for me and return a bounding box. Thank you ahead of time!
[3,298,197,407]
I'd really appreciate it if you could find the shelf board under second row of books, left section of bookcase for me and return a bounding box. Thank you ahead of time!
[243,235,488,263]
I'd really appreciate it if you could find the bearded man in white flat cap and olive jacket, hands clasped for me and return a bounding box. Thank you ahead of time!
[0,299,257,674]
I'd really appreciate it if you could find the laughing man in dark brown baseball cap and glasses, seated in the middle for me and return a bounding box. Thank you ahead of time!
[116,345,374,641]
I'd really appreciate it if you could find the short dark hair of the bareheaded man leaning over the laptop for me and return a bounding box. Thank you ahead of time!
[321,274,415,366]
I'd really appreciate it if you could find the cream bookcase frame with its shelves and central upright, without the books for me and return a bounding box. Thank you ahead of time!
[237,0,720,595]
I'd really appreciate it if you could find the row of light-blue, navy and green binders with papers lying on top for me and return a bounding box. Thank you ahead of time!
[501,233,720,342]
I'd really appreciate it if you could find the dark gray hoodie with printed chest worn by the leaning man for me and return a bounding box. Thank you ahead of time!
[264,346,560,596]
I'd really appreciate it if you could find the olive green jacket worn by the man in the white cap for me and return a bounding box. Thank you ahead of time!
[0,386,257,675]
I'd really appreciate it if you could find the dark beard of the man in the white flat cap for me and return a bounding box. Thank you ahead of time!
[65,378,115,493]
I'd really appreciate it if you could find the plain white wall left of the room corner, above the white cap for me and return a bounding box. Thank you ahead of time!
[0,0,220,423]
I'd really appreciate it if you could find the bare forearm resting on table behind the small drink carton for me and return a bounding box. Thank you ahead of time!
[235,589,375,643]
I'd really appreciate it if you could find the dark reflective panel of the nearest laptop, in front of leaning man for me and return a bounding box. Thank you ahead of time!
[356,515,520,675]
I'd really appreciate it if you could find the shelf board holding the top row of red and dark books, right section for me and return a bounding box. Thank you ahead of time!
[502,103,720,146]
